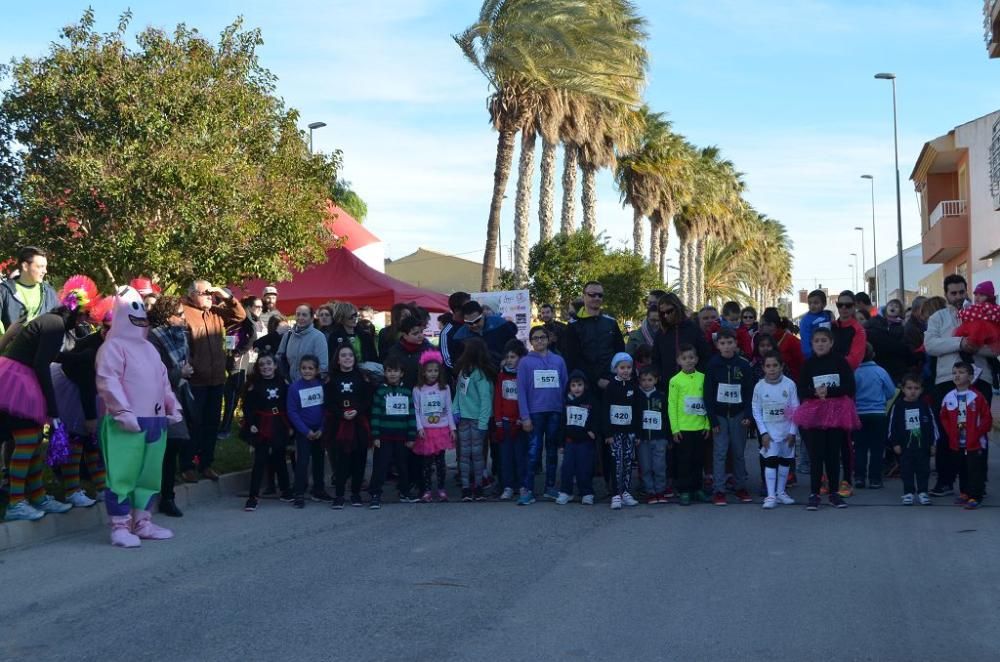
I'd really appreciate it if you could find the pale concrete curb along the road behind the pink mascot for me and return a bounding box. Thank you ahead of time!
[0,471,250,552]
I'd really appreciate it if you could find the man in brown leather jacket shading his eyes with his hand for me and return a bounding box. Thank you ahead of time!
[181,280,246,482]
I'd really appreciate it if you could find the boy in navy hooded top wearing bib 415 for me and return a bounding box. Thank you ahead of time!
[705,329,753,506]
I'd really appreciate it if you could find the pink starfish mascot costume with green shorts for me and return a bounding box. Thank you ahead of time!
[97,287,181,547]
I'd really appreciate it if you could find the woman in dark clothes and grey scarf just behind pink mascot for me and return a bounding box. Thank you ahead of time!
[149,295,194,517]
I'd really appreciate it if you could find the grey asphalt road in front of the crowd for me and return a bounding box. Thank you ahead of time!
[0,456,1000,662]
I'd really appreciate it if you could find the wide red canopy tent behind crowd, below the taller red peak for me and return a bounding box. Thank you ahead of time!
[239,248,448,312]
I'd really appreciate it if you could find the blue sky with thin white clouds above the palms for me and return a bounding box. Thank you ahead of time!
[0,0,1000,289]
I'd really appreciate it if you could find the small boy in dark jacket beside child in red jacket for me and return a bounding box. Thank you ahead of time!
[888,374,939,506]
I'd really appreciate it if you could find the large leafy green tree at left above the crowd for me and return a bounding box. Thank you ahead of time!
[0,10,336,284]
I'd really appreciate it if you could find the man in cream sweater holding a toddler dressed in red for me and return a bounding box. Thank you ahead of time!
[924,274,996,497]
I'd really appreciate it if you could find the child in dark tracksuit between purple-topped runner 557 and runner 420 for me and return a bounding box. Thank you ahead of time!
[556,370,600,506]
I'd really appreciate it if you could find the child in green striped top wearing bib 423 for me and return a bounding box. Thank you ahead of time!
[368,355,419,510]
